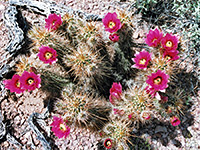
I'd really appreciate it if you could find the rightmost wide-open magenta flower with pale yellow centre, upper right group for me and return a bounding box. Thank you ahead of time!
[161,33,178,51]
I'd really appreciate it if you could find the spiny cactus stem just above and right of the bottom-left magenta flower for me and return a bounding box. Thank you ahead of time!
[55,90,110,130]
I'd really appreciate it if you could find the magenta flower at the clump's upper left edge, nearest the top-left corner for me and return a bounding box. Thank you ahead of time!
[45,14,62,31]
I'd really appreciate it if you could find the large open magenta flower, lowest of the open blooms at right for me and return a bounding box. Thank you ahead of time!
[146,70,169,91]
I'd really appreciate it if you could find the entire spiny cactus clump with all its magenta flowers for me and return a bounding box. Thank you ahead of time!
[1,8,192,149]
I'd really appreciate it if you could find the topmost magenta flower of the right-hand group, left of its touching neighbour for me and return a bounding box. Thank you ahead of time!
[145,28,163,47]
